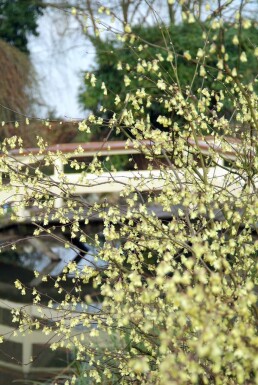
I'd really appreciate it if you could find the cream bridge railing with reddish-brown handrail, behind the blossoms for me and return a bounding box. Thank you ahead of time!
[0,136,250,222]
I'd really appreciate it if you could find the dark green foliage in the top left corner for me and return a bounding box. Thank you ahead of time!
[0,0,42,53]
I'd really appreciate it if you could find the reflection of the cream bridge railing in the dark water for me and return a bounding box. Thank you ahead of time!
[0,299,89,374]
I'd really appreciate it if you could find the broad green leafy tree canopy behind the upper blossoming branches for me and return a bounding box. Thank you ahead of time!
[79,22,258,137]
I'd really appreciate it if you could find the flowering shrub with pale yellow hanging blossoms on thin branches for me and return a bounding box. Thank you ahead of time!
[1,0,258,385]
